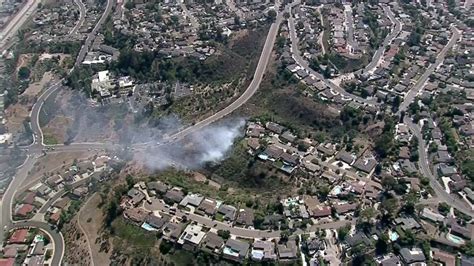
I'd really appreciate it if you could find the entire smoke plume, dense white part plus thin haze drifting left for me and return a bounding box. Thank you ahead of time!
[45,90,245,170]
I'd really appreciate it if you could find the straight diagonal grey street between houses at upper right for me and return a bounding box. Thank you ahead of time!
[397,26,461,114]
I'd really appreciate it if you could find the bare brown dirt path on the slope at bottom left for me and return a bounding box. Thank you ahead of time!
[78,193,110,265]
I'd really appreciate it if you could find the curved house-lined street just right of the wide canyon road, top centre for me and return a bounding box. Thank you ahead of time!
[288,5,378,106]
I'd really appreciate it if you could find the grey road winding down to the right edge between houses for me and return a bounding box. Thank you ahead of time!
[404,116,474,217]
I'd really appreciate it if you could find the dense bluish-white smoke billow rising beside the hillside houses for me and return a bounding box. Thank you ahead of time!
[134,118,245,170]
